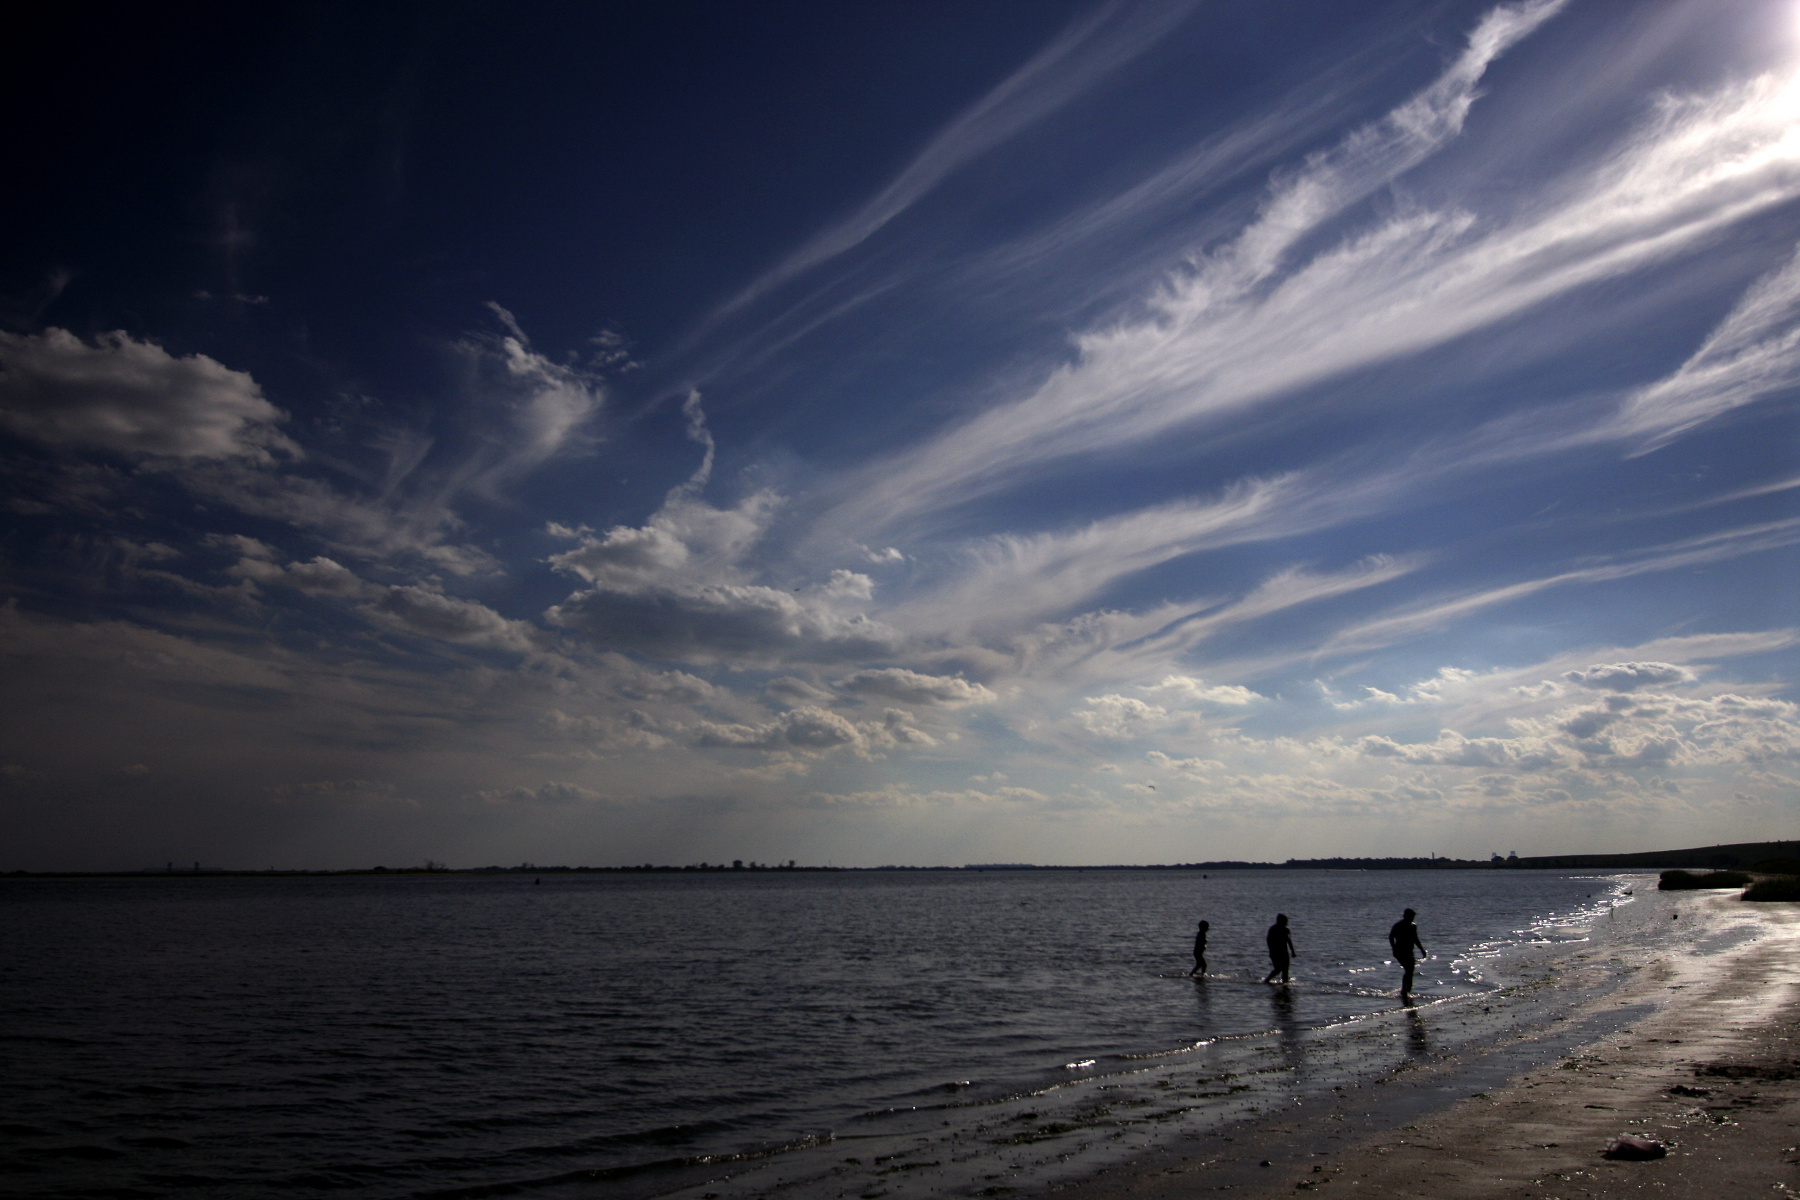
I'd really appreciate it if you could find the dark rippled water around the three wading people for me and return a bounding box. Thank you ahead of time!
[0,871,1615,1196]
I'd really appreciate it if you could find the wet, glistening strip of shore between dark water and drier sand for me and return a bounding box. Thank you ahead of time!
[637,876,1656,1200]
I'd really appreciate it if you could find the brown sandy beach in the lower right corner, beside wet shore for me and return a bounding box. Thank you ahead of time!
[1046,891,1800,1200]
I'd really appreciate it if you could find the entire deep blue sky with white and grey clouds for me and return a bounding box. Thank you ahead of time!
[0,0,1800,871]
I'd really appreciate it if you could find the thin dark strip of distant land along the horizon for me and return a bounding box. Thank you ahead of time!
[0,842,1800,880]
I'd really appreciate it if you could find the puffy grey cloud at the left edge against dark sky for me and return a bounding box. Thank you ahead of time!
[0,327,301,462]
